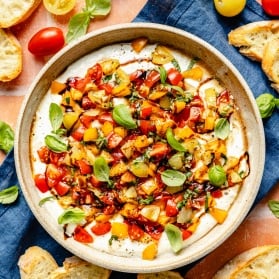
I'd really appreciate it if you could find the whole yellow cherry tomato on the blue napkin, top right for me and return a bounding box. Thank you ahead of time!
[214,0,246,17]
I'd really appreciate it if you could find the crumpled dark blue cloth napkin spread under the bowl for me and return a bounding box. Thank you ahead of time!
[0,0,279,279]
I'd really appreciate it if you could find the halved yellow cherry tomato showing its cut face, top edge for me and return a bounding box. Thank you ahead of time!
[43,0,76,15]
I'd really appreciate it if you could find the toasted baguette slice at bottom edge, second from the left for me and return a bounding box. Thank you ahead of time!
[47,256,111,279]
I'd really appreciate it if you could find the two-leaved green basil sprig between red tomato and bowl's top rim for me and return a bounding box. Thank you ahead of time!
[66,0,111,43]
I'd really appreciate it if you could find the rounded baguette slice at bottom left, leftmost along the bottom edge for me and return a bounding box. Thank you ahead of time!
[18,246,58,279]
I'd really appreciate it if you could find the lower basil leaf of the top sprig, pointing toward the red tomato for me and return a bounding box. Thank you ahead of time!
[66,11,90,43]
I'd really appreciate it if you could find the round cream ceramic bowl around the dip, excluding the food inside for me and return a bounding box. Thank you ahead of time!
[15,23,265,272]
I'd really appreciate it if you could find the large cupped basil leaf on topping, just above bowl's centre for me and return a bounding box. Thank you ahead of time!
[112,104,137,129]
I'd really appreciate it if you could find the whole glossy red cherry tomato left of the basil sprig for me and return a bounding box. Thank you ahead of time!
[28,27,65,56]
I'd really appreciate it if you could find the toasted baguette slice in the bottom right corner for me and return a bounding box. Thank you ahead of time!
[213,245,279,279]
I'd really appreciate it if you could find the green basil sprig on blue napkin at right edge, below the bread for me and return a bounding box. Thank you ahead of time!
[256,93,279,118]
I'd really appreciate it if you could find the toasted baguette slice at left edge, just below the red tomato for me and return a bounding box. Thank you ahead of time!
[0,28,22,82]
